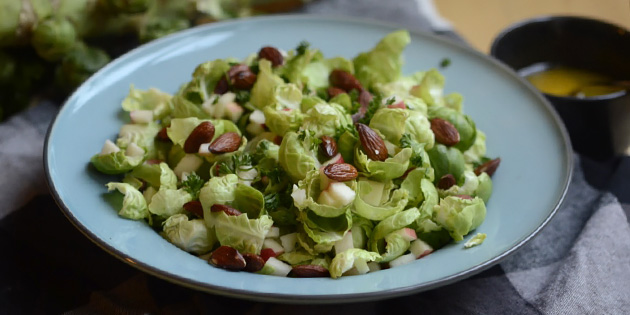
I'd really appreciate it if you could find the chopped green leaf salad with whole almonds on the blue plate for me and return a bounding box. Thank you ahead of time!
[91,30,500,278]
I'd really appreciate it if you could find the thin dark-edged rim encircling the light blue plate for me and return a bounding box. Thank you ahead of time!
[43,13,574,304]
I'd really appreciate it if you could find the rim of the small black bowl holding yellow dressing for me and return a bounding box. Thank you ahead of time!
[489,14,630,104]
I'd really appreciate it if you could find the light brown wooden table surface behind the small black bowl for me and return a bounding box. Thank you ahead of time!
[434,0,630,53]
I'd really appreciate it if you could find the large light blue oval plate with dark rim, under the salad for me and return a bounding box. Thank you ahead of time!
[44,16,572,303]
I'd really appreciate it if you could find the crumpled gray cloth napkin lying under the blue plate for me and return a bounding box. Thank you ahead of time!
[0,0,630,314]
